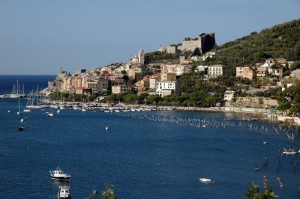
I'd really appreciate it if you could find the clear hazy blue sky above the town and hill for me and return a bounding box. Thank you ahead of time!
[0,0,300,75]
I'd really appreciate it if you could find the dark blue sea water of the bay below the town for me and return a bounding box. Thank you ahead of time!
[0,76,300,199]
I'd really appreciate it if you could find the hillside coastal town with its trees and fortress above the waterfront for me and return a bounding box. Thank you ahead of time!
[2,21,300,125]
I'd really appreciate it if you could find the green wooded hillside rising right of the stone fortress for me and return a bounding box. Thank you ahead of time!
[213,19,300,67]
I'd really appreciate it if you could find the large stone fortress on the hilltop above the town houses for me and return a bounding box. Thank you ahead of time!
[158,33,216,55]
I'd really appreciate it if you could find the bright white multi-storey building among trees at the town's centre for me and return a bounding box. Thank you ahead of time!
[156,81,178,97]
